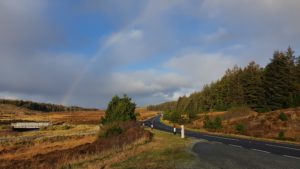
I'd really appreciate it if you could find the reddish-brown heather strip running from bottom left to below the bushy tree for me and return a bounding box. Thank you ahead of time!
[0,123,151,169]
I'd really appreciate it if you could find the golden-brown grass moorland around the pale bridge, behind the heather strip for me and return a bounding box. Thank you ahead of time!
[0,104,156,168]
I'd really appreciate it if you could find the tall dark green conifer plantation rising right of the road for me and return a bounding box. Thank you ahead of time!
[148,47,300,116]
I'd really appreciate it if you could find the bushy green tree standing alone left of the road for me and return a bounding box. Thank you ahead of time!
[101,95,136,124]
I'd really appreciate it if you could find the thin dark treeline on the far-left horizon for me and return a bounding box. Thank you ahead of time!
[0,99,97,112]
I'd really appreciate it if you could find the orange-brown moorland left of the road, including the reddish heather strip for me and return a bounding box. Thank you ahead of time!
[0,104,156,168]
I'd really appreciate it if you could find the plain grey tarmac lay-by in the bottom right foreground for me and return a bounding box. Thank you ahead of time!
[190,141,300,169]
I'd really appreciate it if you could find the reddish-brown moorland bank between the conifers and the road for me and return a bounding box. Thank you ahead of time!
[187,108,300,143]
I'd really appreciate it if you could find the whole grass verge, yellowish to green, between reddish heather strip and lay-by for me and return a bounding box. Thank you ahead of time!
[66,130,199,169]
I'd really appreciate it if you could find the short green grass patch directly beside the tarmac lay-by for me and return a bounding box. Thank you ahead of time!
[112,130,197,169]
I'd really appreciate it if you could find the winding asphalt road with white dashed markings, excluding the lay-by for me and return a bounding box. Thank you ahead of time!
[144,116,300,161]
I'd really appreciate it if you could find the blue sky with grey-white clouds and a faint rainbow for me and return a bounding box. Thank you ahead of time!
[0,0,300,108]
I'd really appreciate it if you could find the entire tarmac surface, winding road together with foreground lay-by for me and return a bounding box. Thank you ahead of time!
[144,116,300,169]
